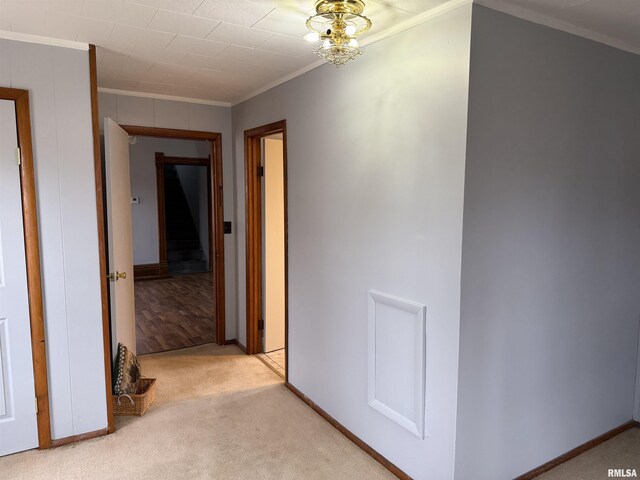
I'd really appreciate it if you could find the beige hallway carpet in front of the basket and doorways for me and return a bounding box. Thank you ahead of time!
[0,345,395,480]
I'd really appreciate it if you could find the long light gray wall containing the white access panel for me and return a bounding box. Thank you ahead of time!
[233,5,471,479]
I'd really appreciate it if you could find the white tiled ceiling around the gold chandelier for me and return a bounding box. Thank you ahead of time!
[0,0,640,103]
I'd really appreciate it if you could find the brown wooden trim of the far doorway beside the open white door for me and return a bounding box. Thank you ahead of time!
[120,125,225,345]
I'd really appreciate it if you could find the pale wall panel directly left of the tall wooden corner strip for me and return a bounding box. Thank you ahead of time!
[52,49,107,434]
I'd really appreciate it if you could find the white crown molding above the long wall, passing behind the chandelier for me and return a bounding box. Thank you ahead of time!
[231,0,473,107]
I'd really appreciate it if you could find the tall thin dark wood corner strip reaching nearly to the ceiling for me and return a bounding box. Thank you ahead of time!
[89,45,115,433]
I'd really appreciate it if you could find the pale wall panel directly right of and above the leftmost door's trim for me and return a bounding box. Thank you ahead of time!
[7,40,75,438]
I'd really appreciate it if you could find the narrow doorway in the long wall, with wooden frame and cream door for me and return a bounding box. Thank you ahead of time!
[245,120,288,380]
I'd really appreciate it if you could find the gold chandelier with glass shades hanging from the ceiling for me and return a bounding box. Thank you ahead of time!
[304,0,371,67]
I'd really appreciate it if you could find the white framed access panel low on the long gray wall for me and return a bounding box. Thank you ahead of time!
[368,290,427,438]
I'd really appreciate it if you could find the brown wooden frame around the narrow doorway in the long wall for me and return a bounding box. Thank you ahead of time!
[244,120,289,372]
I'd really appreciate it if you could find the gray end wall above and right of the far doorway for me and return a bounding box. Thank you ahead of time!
[99,93,237,340]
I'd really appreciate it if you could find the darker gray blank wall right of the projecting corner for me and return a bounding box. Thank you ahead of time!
[456,6,640,480]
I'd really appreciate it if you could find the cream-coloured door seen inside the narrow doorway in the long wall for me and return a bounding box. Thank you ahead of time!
[262,138,285,352]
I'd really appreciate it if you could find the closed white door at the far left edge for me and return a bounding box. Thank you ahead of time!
[0,100,38,455]
